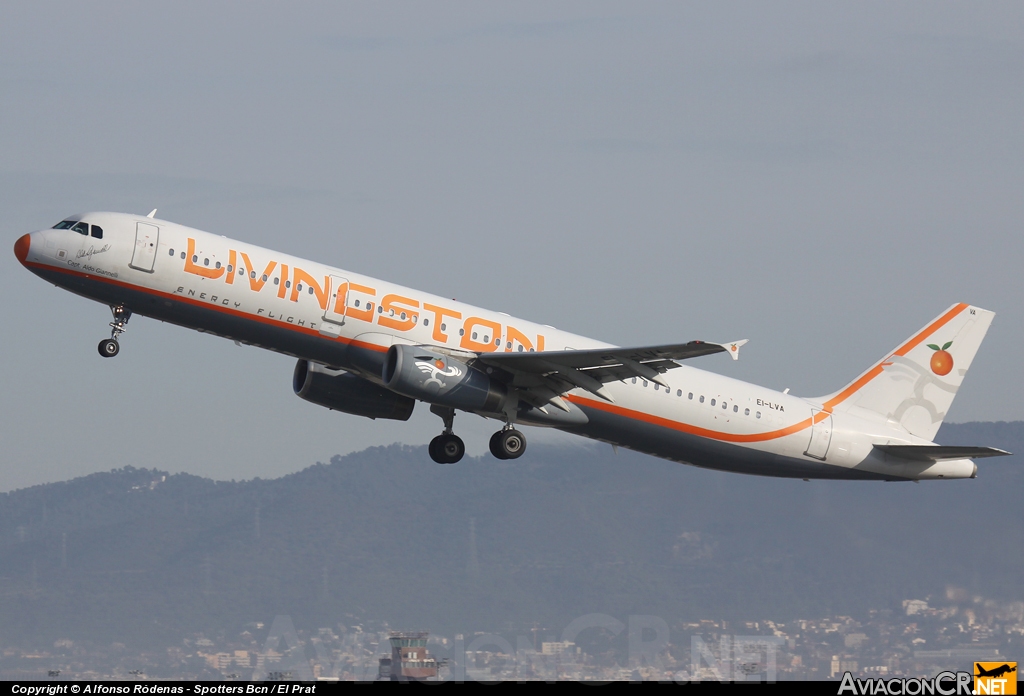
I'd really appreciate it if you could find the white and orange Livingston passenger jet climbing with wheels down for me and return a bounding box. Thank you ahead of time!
[14,210,1010,481]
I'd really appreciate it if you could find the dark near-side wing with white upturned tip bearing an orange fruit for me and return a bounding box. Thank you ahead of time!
[477,340,746,408]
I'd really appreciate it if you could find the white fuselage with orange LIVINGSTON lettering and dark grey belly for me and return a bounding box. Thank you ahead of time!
[15,213,975,480]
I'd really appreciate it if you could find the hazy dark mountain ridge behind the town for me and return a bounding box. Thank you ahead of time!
[0,423,1024,646]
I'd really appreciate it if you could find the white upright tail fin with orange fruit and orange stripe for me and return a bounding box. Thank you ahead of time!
[820,304,995,440]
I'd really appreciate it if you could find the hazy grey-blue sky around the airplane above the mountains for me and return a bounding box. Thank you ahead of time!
[0,0,1024,490]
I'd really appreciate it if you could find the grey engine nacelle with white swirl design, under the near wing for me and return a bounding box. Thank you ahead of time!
[381,346,508,414]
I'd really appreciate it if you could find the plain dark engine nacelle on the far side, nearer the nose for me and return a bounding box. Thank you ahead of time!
[292,360,416,421]
